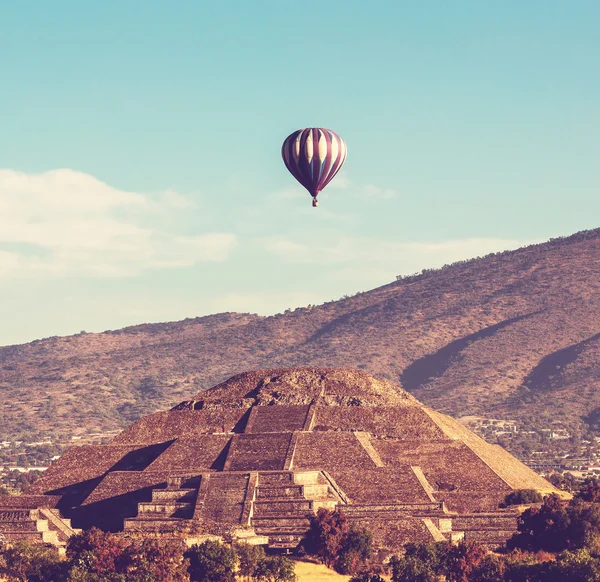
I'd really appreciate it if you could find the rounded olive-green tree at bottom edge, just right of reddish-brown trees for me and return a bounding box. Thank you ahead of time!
[186,540,237,582]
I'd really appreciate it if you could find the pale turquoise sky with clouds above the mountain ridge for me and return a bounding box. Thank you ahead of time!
[0,0,600,345]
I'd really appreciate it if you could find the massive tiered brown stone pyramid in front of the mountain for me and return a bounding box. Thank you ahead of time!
[9,368,555,552]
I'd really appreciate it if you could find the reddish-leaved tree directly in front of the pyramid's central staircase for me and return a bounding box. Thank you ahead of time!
[302,508,350,568]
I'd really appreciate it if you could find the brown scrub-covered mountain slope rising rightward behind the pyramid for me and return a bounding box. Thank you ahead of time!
[0,229,600,448]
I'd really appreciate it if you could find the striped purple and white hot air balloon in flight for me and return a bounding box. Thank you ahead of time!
[281,127,346,206]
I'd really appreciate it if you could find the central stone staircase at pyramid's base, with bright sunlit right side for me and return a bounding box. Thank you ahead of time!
[250,471,342,549]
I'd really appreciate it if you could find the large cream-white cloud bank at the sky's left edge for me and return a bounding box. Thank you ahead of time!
[0,169,236,277]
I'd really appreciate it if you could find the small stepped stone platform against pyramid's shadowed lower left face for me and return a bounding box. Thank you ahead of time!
[124,476,200,533]
